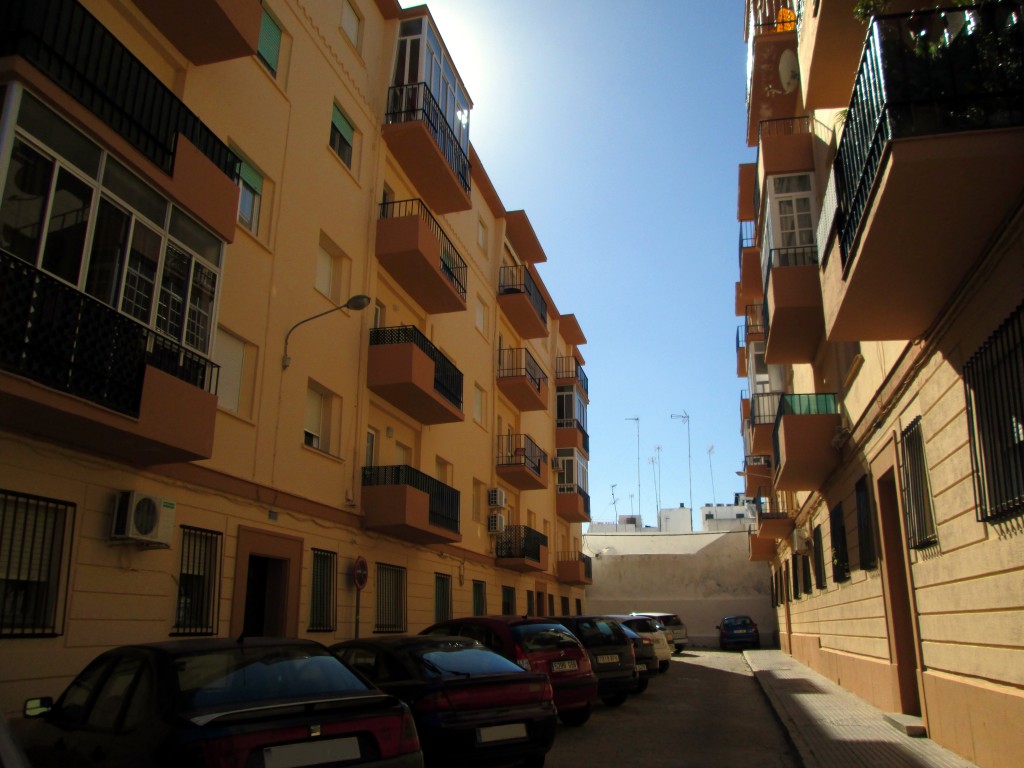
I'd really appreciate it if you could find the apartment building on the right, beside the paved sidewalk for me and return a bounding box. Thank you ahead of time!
[736,0,1024,766]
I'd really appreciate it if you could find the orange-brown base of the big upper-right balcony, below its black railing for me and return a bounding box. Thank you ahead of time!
[822,128,1024,341]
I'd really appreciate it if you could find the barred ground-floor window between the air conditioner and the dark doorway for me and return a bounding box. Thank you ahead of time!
[171,525,223,636]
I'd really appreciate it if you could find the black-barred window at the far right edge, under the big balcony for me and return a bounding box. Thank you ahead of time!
[964,304,1024,521]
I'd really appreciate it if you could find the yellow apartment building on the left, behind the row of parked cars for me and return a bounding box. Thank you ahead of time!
[0,0,591,714]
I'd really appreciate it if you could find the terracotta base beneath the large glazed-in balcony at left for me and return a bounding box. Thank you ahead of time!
[0,366,217,466]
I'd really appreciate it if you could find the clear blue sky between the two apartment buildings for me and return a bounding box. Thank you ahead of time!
[401,0,755,524]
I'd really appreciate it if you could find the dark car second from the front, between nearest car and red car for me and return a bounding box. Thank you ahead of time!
[331,635,557,768]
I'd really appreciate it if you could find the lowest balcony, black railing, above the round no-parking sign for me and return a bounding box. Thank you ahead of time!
[362,465,462,544]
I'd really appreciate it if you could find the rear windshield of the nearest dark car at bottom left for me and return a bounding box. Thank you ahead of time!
[174,645,370,711]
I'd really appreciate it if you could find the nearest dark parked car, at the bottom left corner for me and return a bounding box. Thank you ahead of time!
[17,638,423,768]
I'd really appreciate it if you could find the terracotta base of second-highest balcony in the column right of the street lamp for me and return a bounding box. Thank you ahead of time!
[377,216,466,314]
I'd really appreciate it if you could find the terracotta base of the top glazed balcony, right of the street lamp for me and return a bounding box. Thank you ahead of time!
[382,120,472,213]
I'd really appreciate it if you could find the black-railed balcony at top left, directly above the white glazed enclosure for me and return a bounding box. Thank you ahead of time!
[0,0,240,242]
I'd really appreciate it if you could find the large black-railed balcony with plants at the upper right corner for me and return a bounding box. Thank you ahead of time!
[822,2,1024,341]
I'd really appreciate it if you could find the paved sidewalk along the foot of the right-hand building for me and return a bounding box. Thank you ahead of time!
[743,650,977,768]
